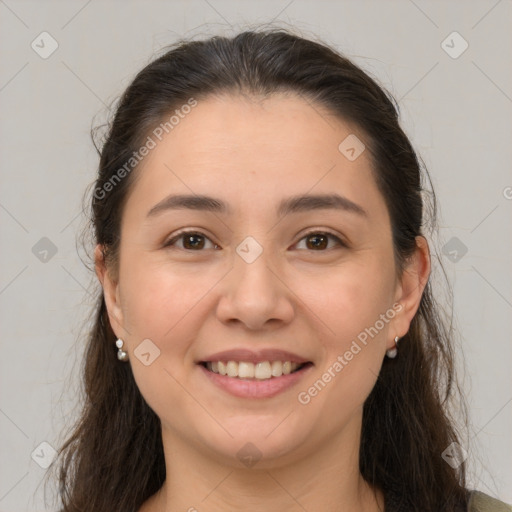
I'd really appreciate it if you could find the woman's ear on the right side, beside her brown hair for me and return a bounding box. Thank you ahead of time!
[387,236,431,349]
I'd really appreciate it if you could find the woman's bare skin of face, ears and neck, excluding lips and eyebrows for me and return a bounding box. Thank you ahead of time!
[96,94,430,512]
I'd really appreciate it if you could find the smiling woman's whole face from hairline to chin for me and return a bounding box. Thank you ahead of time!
[100,95,422,466]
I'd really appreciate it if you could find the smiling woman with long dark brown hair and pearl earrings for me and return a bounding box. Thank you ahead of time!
[51,30,510,512]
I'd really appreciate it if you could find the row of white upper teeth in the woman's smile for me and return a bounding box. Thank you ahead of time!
[206,361,301,380]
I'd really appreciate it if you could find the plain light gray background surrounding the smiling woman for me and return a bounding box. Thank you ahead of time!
[0,0,512,512]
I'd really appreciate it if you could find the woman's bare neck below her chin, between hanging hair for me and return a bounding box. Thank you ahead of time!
[140,414,384,512]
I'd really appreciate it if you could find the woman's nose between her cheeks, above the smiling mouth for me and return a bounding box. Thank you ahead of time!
[217,245,295,330]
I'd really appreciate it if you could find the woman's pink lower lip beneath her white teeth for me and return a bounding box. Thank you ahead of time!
[198,364,313,398]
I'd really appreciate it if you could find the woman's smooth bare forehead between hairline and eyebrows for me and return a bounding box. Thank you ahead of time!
[124,94,384,224]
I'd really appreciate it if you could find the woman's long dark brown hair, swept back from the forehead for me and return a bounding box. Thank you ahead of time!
[48,29,465,512]
